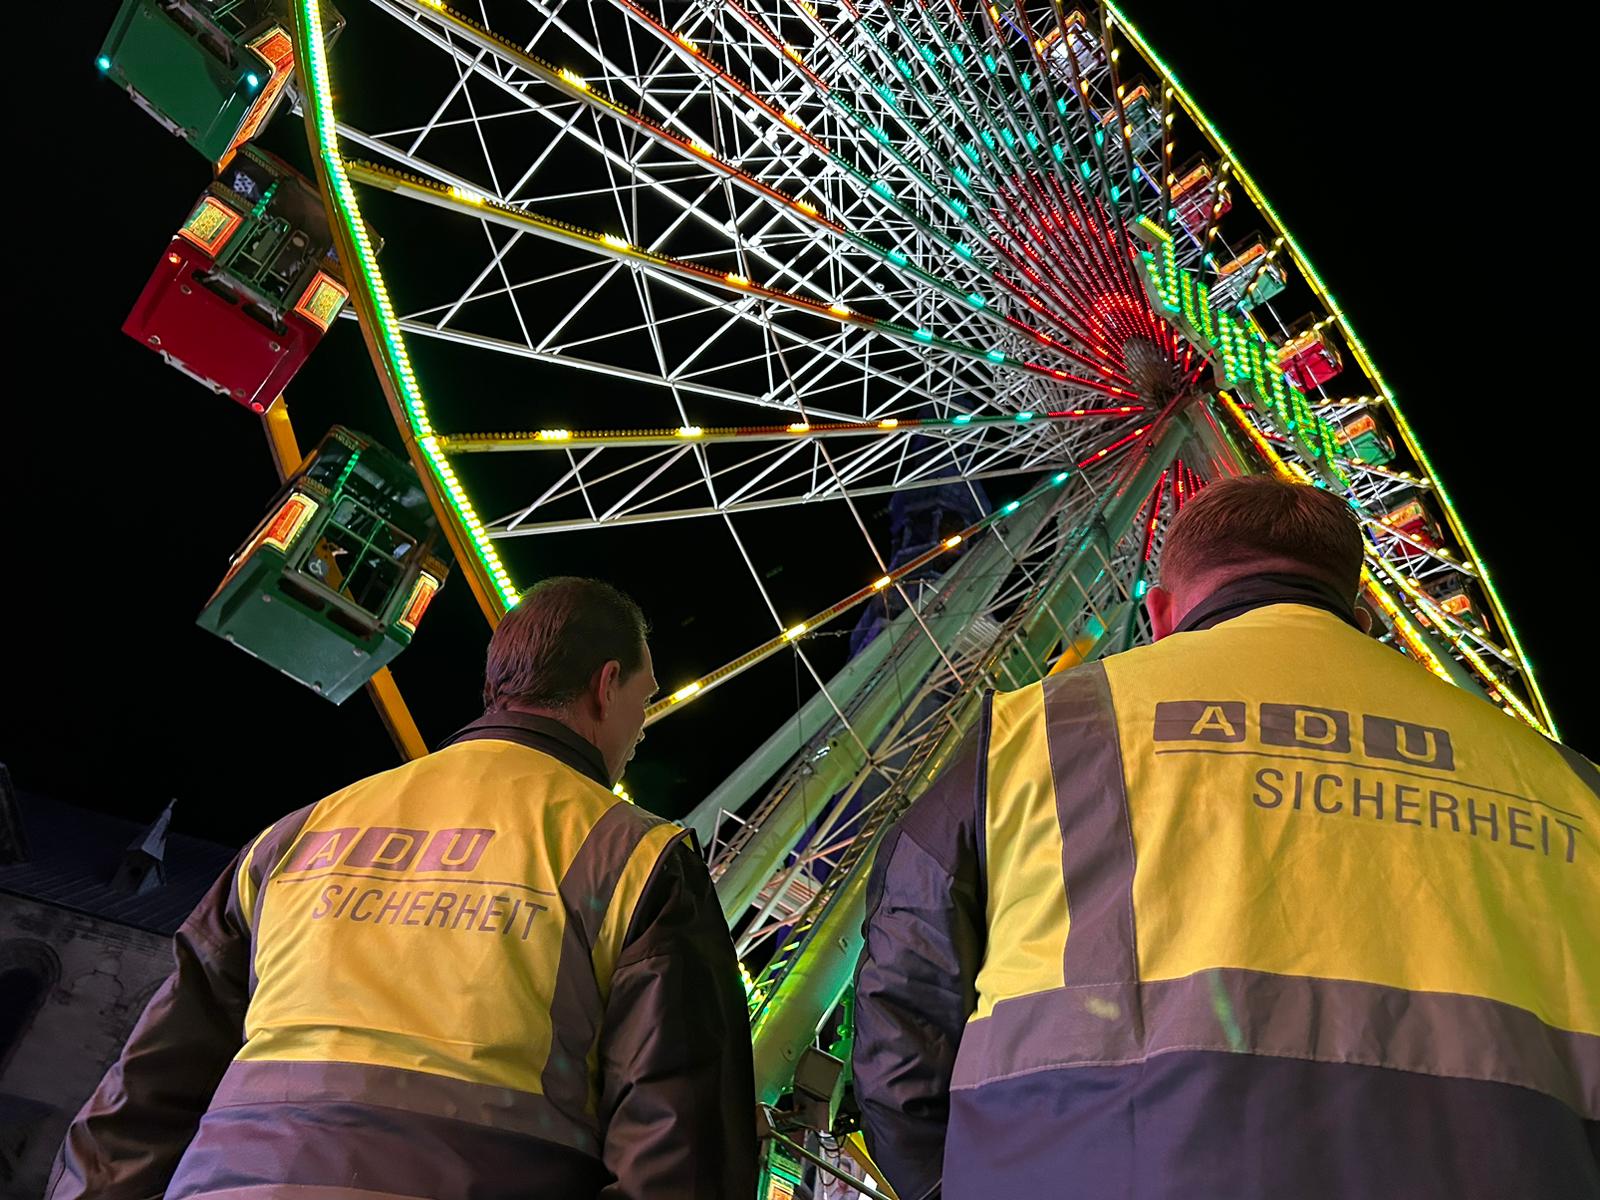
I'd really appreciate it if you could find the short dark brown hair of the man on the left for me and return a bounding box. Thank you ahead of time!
[483,576,650,709]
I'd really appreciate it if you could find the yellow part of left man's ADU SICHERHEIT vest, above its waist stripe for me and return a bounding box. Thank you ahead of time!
[230,739,685,1152]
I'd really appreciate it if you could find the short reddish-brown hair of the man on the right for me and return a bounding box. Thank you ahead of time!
[1162,475,1363,595]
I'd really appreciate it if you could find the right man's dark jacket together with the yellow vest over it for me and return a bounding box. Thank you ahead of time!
[854,579,1600,1200]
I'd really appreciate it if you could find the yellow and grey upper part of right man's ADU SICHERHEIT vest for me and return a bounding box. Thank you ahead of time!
[952,603,1600,1120]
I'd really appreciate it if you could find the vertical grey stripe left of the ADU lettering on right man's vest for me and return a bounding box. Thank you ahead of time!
[1043,662,1139,986]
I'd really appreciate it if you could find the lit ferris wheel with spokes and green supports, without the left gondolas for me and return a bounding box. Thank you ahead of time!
[101,0,1555,1190]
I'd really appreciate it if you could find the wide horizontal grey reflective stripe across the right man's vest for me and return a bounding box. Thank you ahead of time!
[950,968,1600,1120]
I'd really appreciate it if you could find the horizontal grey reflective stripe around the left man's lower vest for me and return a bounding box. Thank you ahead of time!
[211,1061,600,1155]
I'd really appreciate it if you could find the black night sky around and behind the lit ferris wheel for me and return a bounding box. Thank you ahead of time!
[0,0,1600,842]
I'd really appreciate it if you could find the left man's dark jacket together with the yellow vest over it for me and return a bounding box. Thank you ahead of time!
[48,712,755,1200]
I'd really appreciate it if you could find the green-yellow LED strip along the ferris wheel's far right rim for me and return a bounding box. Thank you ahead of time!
[1106,0,1560,738]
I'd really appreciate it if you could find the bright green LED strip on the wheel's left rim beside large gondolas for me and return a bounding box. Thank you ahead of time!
[286,0,518,611]
